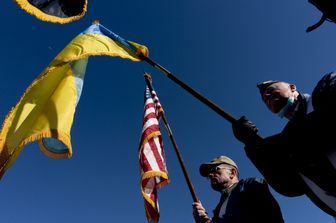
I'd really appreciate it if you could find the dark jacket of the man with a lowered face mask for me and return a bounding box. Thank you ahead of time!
[245,73,336,216]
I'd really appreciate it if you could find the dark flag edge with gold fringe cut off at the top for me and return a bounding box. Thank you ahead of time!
[15,0,87,24]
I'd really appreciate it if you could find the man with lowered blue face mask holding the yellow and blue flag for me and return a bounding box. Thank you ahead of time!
[232,72,336,216]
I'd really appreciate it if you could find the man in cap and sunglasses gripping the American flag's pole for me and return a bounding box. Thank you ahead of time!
[192,156,284,223]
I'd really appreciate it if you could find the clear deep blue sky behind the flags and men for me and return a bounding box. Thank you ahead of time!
[0,0,336,223]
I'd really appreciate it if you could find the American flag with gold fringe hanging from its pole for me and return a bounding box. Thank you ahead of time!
[139,86,169,223]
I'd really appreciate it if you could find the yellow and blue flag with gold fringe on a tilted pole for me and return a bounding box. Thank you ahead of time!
[0,24,148,176]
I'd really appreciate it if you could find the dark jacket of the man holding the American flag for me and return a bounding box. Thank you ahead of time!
[212,178,284,223]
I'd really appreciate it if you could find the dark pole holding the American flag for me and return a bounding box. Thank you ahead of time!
[144,73,199,202]
